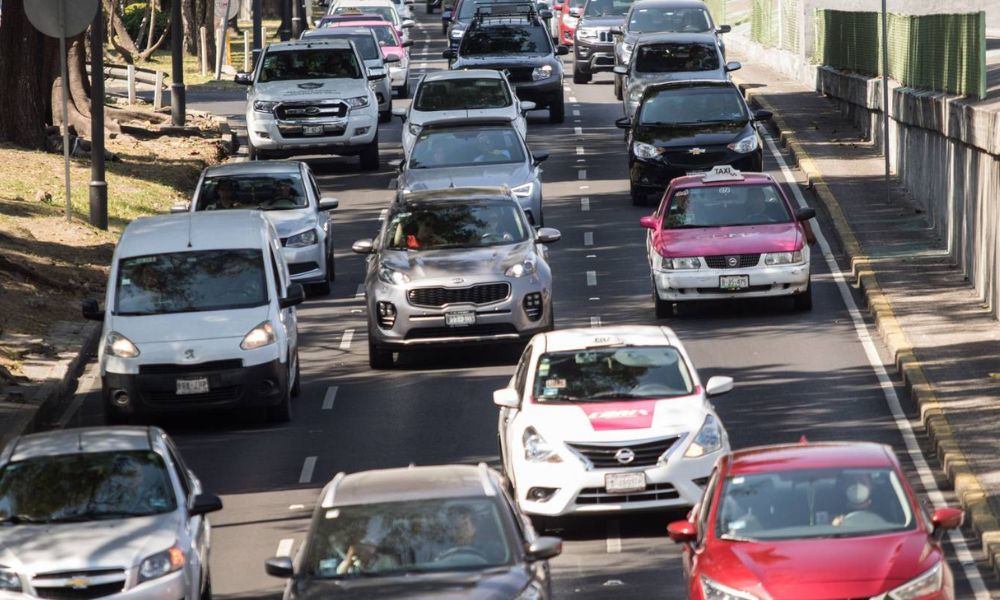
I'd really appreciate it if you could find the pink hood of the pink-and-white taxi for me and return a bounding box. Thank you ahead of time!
[655,222,803,256]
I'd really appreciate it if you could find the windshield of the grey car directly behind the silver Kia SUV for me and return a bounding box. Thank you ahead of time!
[408,127,524,169]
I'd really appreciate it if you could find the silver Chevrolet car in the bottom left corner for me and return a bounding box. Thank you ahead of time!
[0,427,222,600]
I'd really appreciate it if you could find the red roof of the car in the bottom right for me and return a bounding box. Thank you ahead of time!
[729,442,898,475]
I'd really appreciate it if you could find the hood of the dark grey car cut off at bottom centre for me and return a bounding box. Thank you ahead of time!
[292,567,528,600]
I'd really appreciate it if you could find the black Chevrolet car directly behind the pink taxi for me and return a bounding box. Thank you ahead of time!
[615,81,771,205]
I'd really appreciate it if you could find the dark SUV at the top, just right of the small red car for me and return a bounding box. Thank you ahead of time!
[573,0,632,83]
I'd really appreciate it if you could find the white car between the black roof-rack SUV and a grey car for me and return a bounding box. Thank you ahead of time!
[393,69,535,157]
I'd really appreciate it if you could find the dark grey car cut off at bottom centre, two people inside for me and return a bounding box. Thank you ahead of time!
[266,464,562,600]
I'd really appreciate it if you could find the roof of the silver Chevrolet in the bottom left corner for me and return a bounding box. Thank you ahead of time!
[4,427,153,462]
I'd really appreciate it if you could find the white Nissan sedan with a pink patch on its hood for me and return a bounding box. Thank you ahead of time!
[493,326,733,518]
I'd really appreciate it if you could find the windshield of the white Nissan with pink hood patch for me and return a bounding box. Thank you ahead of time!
[534,346,694,404]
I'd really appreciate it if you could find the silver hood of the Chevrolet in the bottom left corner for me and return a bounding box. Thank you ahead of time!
[0,511,181,573]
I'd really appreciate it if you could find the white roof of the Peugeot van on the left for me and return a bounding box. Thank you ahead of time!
[116,210,269,260]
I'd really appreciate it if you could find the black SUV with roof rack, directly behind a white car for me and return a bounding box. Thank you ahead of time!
[442,0,569,123]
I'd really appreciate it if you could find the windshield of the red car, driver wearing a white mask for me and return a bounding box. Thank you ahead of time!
[716,468,915,541]
